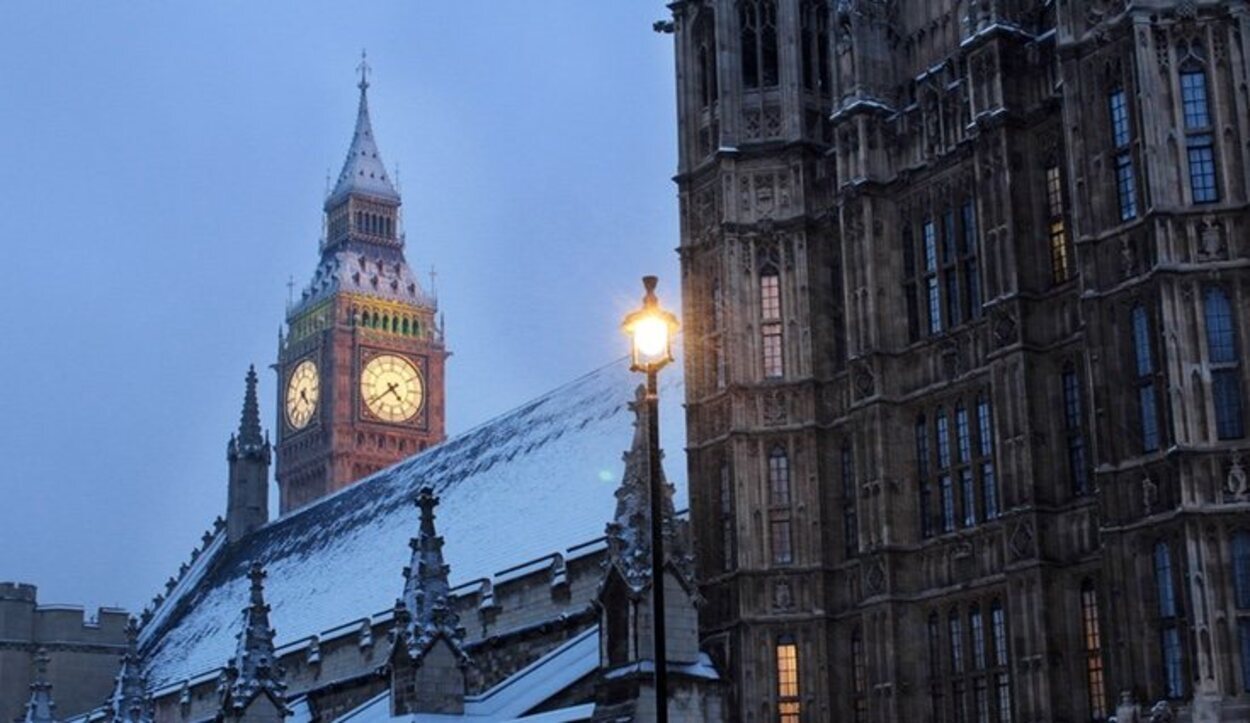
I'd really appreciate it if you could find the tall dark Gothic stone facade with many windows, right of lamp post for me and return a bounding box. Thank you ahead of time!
[658,0,1250,722]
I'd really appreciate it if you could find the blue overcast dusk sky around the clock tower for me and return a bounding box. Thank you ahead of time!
[0,0,679,610]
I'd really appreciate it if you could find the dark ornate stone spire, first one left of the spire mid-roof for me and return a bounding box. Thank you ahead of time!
[218,563,286,717]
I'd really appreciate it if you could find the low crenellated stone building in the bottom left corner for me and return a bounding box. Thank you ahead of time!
[0,583,129,720]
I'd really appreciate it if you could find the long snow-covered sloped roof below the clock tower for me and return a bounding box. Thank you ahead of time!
[140,360,686,688]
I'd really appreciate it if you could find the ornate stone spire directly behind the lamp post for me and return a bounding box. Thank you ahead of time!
[606,384,694,590]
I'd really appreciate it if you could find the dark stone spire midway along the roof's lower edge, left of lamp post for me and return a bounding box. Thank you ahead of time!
[395,487,468,660]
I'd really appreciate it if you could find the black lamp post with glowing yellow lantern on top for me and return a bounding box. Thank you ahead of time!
[623,276,678,723]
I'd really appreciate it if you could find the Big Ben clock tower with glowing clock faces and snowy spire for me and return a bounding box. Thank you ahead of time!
[276,63,448,514]
